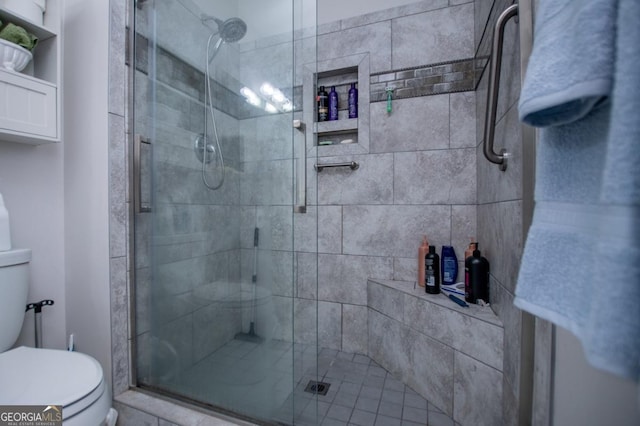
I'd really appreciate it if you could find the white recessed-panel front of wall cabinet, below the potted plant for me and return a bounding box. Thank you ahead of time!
[0,71,58,138]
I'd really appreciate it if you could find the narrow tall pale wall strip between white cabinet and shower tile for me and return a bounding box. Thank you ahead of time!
[63,0,111,377]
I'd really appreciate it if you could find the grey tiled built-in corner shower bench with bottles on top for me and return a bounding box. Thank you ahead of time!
[367,278,504,425]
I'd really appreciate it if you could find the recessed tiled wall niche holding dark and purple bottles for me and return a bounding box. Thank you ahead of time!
[303,54,369,157]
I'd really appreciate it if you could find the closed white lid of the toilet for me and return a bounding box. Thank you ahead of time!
[0,346,105,418]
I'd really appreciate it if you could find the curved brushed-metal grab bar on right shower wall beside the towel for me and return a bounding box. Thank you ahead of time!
[483,4,518,172]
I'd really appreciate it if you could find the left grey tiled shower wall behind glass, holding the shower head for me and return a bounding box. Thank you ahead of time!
[134,2,248,384]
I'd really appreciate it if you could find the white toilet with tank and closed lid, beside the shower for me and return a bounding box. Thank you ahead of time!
[0,249,117,426]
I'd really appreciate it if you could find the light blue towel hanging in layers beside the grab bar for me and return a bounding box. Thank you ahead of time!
[515,0,640,381]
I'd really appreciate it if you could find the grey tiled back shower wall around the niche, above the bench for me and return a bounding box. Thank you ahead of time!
[258,0,477,354]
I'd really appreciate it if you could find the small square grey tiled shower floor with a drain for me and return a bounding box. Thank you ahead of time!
[171,340,454,426]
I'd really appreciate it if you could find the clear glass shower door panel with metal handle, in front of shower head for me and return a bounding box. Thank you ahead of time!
[133,0,317,424]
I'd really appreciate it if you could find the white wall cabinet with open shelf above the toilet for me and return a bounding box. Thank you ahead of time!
[0,1,62,145]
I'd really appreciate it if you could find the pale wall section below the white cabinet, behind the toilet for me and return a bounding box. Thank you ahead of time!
[0,141,65,349]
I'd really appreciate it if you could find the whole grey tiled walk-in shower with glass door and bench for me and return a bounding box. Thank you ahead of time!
[131,0,521,426]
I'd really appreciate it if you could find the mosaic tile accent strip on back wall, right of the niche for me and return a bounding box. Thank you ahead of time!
[370,58,476,102]
